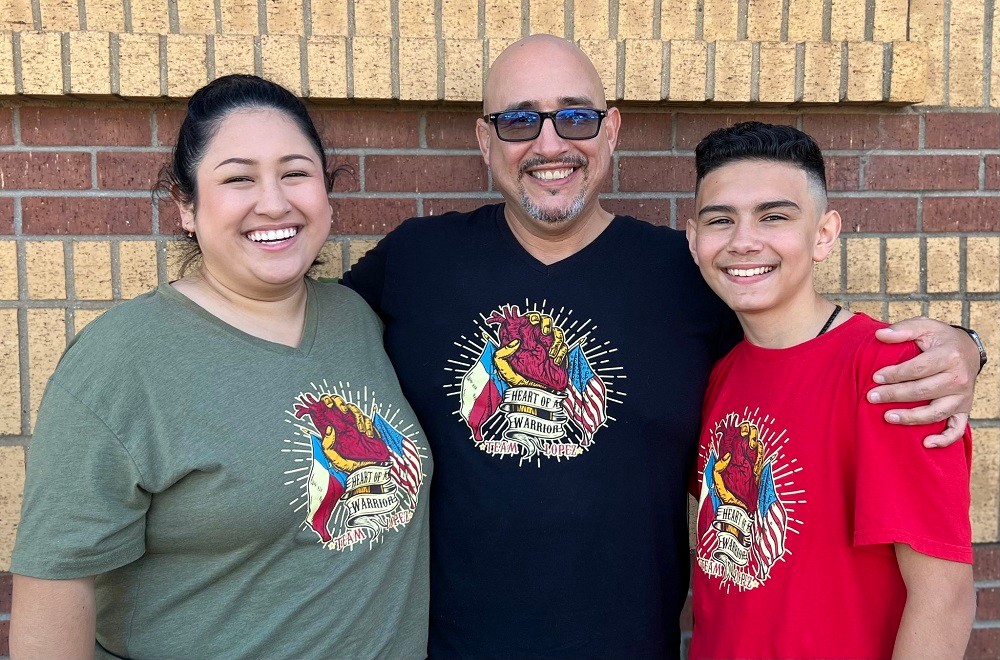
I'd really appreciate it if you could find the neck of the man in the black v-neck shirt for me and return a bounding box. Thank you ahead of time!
[504,202,614,266]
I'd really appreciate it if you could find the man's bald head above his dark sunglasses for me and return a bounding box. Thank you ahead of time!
[483,34,607,114]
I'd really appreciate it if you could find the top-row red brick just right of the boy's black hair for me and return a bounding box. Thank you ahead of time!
[802,114,920,149]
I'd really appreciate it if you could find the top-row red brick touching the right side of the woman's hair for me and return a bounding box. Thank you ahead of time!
[310,108,420,150]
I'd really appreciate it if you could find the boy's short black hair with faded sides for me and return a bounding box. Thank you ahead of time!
[694,121,826,195]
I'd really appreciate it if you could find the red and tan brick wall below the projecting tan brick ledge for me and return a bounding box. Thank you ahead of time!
[0,101,1000,658]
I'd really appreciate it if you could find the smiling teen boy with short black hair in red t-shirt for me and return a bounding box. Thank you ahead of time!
[687,122,975,658]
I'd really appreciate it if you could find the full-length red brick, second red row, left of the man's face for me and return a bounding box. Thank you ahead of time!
[365,156,486,193]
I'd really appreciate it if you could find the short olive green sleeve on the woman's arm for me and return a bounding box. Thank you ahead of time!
[10,380,150,579]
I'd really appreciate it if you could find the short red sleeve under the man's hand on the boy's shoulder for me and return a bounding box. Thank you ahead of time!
[854,340,972,563]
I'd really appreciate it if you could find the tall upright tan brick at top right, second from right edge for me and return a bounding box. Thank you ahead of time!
[948,2,984,107]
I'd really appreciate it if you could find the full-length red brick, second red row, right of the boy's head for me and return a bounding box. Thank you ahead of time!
[865,156,979,190]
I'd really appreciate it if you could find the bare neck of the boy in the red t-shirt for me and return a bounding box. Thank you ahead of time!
[736,291,852,348]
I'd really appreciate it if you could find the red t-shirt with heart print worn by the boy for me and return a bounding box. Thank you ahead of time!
[690,314,972,658]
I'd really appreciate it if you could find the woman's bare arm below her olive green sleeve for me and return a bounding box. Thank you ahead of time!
[10,575,96,660]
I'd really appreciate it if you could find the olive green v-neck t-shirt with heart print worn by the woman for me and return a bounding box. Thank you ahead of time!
[11,281,431,658]
